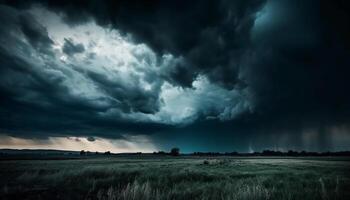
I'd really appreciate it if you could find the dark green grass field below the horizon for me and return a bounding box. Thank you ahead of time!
[0,156,350,200]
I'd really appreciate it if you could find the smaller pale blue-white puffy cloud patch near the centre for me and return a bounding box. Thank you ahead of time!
[154,76,251,124]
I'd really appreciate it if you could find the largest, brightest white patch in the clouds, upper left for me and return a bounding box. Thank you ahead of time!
[31,7,166,111]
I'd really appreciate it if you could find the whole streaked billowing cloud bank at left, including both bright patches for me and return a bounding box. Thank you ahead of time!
[1,6,248,137]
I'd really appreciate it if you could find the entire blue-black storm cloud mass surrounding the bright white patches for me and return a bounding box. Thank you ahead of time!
[0,0,350,150]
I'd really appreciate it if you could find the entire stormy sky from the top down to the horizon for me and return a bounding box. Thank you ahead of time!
[0,0,350,152]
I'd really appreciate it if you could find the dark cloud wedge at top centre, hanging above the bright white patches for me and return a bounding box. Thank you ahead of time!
[1,0,264,88]
